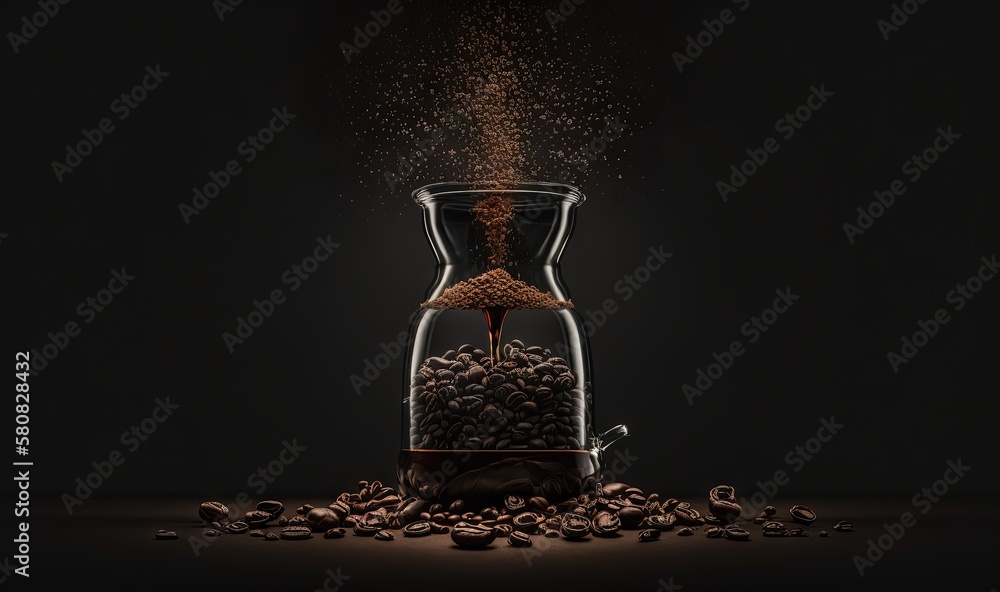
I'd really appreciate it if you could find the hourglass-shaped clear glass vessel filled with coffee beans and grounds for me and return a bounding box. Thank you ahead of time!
[397,183,604,507]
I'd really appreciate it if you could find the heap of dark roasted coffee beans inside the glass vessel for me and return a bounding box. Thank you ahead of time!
[410,339,593,450]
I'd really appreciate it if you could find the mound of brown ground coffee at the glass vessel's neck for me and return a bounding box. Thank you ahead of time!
[420,269,573,310]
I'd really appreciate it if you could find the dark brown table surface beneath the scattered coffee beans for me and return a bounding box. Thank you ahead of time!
[15,496,1000,592]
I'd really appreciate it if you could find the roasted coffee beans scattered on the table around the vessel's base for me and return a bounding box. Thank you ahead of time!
[172,481,854,548]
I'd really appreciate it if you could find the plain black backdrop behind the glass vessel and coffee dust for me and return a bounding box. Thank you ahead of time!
[0,1,1000,513]
